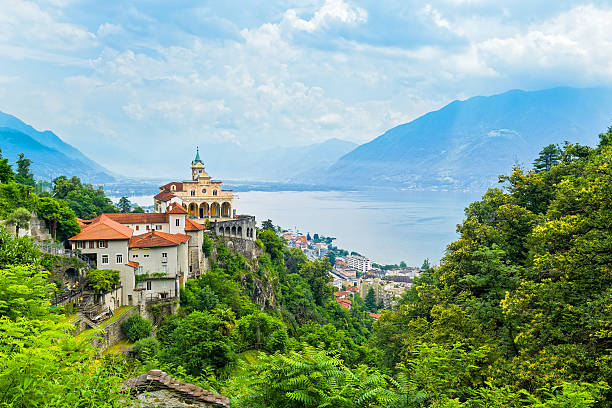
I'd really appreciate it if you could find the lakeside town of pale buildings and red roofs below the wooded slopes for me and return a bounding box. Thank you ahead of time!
[278,230,427,312]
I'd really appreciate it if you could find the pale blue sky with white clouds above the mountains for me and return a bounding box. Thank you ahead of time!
[0,0,612,176]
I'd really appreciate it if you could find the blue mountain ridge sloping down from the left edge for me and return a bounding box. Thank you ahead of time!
[0,112,115,183]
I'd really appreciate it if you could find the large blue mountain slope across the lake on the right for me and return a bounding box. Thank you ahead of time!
[324,88,612,189]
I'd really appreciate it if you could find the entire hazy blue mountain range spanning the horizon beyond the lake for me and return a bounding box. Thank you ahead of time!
[0,87,612,191]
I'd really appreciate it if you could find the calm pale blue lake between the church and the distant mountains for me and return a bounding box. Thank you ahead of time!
[115,191,482,266]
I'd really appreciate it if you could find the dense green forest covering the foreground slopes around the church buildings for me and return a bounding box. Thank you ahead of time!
[0,130,612,408]
